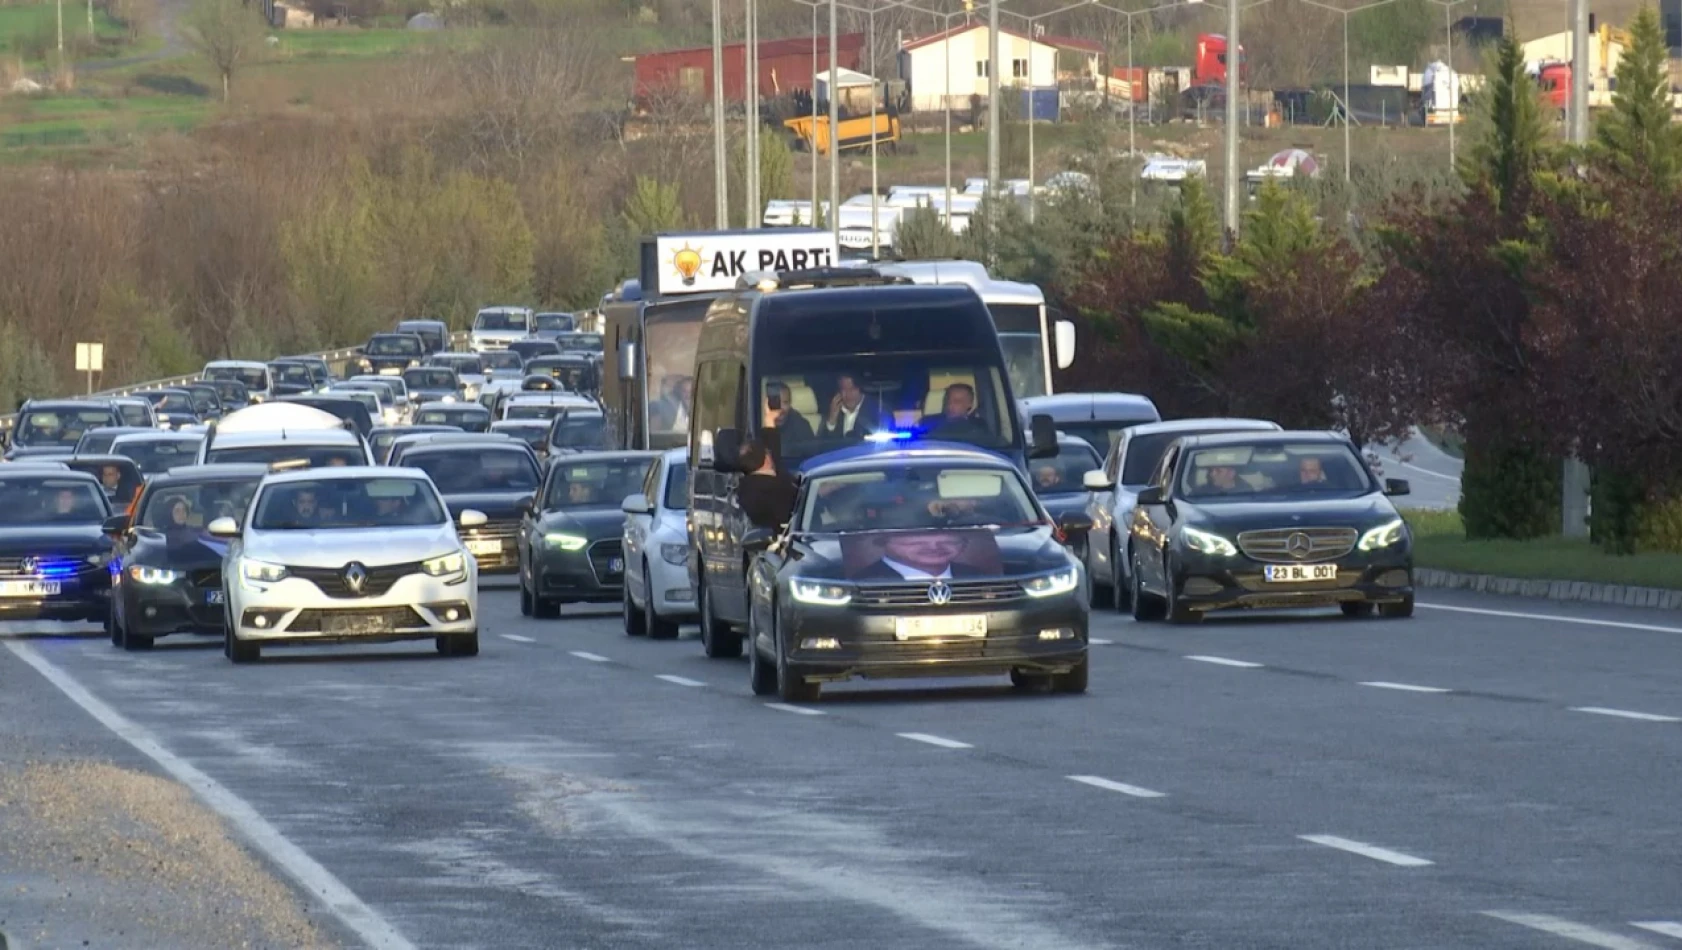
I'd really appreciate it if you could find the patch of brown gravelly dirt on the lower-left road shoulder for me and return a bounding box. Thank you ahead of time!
[0,762,333,948]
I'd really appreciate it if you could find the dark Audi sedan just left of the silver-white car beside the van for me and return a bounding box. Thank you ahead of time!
[520,452,659,617]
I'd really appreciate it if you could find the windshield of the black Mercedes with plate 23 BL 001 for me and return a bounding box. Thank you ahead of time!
[1177,442,1374,503]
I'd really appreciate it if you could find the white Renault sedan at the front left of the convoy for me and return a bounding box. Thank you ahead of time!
[207,466,486,662]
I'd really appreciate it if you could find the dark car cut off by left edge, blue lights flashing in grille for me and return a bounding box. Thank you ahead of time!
[0,466,111,624]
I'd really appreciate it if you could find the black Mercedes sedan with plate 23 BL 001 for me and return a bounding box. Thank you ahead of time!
[1130,432,1413,624]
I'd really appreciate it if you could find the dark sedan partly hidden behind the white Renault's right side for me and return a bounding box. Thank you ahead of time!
[402,439,540,577]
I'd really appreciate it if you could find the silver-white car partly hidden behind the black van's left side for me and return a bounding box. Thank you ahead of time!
[624,449,698,641]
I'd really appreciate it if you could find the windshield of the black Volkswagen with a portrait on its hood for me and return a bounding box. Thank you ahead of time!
[801,462,1039,531]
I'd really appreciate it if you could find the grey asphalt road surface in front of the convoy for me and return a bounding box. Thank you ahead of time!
[0,578,1682,950]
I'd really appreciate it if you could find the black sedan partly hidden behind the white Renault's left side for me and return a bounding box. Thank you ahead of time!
[108,464,269,649]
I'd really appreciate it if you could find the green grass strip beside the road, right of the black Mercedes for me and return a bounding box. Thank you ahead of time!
[1403,509,1682,590]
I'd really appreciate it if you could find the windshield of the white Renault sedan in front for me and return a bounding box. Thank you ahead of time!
[252,478,447,531]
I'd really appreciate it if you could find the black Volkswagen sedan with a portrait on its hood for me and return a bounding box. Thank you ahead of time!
[742,449,1088,703]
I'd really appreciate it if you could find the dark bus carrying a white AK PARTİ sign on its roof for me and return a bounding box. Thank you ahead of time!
[600,227,839,451]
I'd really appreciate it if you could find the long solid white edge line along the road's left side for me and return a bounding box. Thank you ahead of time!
[5,641,414,950]
